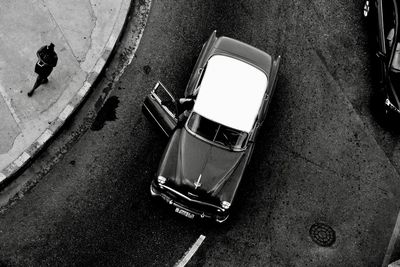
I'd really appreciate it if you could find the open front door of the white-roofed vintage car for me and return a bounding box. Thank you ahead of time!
[142,81,178,137]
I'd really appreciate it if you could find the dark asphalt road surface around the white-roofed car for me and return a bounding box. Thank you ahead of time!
[0,0,400,266]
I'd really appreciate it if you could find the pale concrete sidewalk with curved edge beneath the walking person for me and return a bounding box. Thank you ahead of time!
[0,0,131,185]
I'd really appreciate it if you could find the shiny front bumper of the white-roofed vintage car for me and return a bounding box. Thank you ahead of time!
[150,181,229,223]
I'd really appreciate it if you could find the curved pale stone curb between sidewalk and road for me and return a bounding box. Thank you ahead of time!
[0,0,134,188]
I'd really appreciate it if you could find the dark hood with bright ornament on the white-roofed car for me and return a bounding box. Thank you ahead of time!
[175,129,244,196]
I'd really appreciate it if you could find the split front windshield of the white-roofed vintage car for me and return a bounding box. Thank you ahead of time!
[187,112,248,149]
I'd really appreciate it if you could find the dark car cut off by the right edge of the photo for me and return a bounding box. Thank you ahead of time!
[364,0,400,118]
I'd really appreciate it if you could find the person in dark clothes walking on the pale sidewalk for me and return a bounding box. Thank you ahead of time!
[28,43,58,96]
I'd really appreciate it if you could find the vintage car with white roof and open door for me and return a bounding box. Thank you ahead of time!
[142,31,280,222]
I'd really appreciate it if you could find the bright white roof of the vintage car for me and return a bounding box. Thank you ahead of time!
[193,55,268,133]
